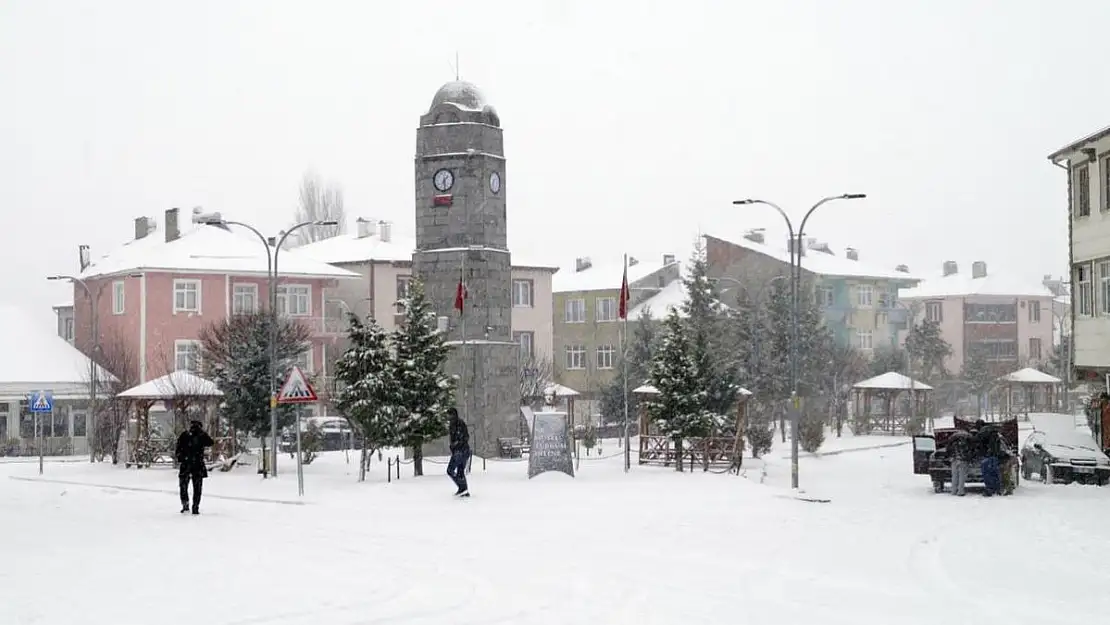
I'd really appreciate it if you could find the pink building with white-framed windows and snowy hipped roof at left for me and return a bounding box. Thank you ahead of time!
[64,209,359,412]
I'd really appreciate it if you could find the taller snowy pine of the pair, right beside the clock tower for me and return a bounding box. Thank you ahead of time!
[393,279,455,475]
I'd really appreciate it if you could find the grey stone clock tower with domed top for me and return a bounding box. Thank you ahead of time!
[413,81,521,456]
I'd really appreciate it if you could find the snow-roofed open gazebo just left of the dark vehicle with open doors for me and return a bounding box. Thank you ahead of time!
[851,371,932,434]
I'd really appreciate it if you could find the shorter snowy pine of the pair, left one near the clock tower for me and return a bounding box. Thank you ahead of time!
[335,314,400,482]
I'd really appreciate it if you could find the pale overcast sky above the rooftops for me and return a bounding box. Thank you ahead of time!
[0,0,1110,313]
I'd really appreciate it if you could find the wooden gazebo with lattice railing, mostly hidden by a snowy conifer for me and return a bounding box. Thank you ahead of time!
[633,384,751,471]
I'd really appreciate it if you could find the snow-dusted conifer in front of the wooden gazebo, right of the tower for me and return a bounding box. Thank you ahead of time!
[647,310,722,471]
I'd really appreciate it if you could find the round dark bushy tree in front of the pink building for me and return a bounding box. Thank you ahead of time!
[199,312,311,475]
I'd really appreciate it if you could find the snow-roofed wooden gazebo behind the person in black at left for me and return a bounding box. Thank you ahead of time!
[115,371,225,467]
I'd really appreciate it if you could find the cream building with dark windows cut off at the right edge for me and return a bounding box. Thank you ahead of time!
[1048,128,1110,382]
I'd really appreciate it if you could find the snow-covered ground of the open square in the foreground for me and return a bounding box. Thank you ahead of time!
[0,426,1110,625]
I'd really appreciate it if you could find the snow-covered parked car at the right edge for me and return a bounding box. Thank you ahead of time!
[1021,430,1110,486]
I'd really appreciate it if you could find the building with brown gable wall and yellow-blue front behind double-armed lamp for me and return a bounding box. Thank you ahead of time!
[705,231,919,353]
